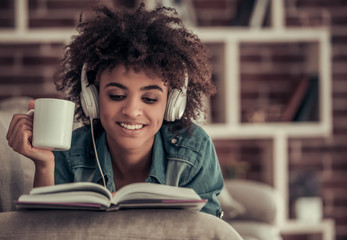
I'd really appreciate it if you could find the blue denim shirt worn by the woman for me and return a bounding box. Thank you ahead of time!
[54,124,223,217]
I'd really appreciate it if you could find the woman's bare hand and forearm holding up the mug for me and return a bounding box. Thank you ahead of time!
[6,100,54,187]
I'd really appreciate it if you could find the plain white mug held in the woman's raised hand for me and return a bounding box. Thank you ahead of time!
[27,98,75,151]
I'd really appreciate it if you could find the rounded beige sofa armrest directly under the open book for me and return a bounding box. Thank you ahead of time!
[0,209,242,240]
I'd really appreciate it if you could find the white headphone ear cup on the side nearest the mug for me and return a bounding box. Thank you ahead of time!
[80,84,99,119]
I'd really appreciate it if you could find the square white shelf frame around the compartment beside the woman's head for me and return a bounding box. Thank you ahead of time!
[196,28,332,138]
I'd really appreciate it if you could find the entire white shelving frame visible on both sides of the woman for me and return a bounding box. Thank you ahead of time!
[0,0,334,237]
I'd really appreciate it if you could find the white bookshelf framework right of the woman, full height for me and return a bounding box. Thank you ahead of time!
[194,0,335,240]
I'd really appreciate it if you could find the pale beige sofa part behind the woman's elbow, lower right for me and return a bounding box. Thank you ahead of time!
[219,179,282,240]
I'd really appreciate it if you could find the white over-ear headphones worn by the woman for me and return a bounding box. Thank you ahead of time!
[80,63,189,122]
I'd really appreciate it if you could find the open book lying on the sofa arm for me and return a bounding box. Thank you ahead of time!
[16,182,207,211]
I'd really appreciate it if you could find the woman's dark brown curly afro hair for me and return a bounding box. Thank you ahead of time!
[55,4,215,126]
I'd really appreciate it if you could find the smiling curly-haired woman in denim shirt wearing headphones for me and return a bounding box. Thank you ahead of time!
[7,5,223,216]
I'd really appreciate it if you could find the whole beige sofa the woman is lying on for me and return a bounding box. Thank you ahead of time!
[0,97,280,240]
